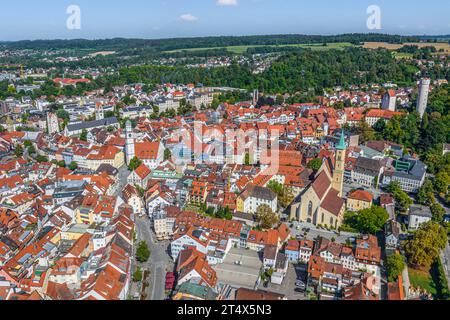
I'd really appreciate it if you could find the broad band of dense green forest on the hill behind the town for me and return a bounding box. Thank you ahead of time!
[90,48,419,94]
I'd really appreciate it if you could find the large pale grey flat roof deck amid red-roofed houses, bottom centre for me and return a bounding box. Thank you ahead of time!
[213,248,263,289]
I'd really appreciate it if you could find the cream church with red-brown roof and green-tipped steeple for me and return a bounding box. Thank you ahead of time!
[290,131,347,228]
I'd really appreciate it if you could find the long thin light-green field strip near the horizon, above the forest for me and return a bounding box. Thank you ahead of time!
[165,42,354,54]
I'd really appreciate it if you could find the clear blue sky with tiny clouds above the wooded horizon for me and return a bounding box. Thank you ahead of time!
[0,0,450,41]
